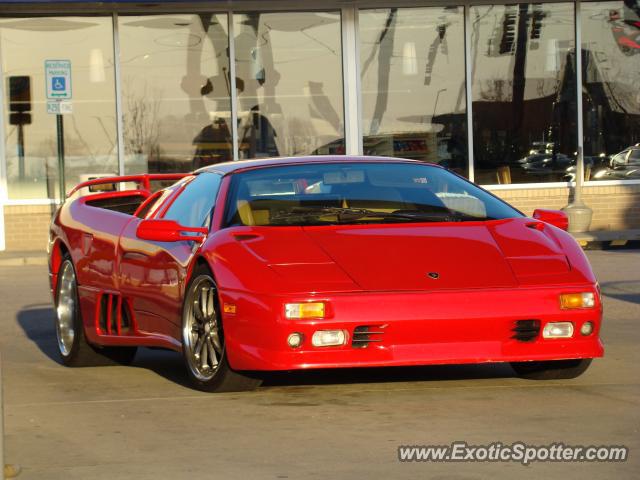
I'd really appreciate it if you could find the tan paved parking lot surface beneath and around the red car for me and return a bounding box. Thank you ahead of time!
[0,250,640,480]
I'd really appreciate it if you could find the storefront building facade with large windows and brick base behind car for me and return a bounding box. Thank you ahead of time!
[0,0,640,250]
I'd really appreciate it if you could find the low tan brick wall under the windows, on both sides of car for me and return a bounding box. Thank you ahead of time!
[4,185,640,251]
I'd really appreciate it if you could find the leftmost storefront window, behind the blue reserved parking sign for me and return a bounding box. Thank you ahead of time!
[0,17,118,199]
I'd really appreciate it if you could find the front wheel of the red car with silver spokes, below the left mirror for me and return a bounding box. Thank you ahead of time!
[181,266,262,392]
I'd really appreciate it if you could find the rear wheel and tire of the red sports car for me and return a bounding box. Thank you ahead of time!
[54,254,137,367]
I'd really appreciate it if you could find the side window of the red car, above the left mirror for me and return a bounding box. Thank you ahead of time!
[163,172,222,227]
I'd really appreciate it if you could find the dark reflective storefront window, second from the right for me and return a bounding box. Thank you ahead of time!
[470,3,577,184]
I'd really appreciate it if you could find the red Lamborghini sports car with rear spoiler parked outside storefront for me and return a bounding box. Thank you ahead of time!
[49,157,603,391]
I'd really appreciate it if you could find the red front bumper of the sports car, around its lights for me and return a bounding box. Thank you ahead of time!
[221,285,603,370]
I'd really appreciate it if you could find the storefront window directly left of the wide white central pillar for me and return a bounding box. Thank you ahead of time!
[233,12,344,158]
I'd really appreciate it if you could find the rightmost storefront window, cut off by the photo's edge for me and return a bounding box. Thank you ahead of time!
[581,1,640,180]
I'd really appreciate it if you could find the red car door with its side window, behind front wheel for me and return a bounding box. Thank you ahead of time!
[119,172,221,339]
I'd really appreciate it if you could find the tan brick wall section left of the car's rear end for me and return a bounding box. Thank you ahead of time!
[4,205,56,251]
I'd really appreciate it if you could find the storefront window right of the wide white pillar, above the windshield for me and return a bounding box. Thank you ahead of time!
[359,6,468,176]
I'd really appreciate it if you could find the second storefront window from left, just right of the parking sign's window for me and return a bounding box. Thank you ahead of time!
[118,14,233,173]
